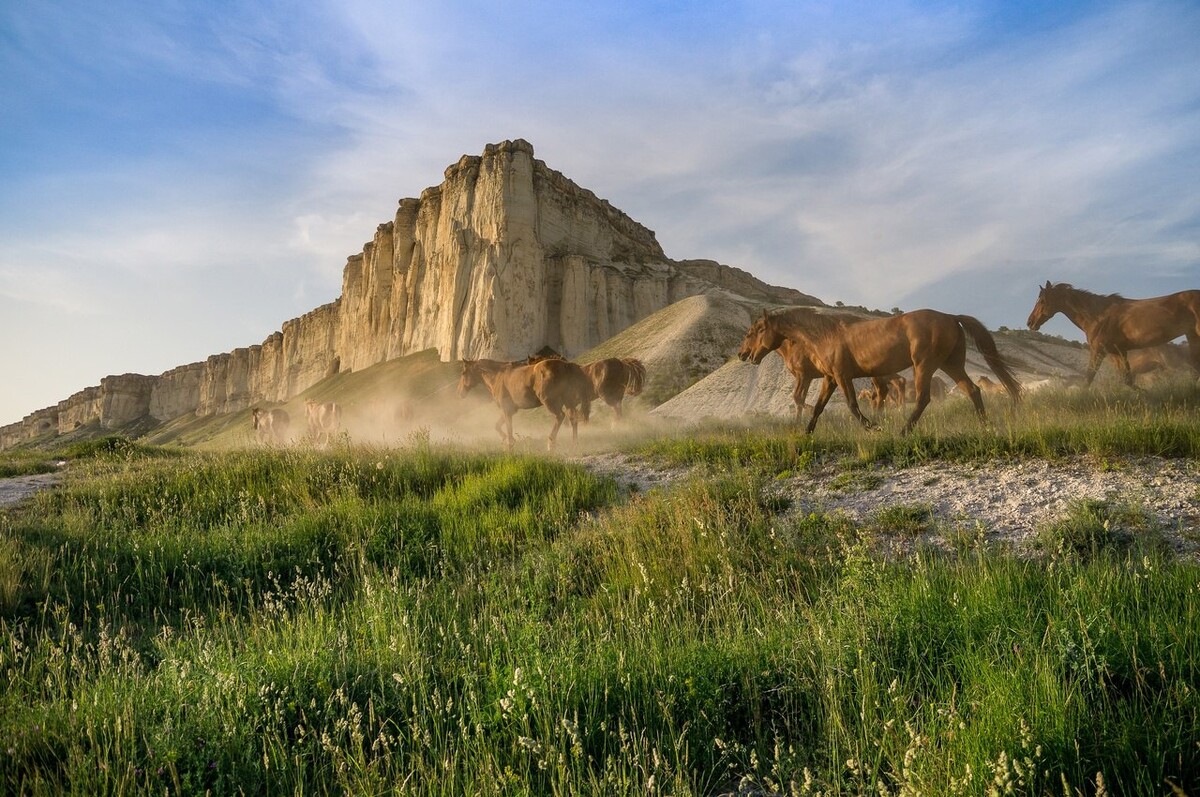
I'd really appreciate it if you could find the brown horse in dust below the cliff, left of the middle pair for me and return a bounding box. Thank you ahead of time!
[458,359,592,451]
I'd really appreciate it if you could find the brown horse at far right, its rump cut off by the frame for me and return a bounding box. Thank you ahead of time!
[1027,280,1200,388]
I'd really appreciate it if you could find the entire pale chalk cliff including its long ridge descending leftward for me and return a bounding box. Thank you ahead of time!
[0,140,821,447]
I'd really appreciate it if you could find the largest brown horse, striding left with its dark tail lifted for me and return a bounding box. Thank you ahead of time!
[738,308,1021,433]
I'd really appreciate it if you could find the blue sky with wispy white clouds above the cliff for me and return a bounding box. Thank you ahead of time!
[0,0,1200,424]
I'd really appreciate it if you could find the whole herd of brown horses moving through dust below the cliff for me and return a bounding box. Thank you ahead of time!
[252,281,1200,450]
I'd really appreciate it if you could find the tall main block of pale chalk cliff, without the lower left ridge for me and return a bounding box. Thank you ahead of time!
[338,140,820,370]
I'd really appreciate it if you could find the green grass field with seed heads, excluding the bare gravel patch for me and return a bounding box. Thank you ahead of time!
[0,389,1200,795]
